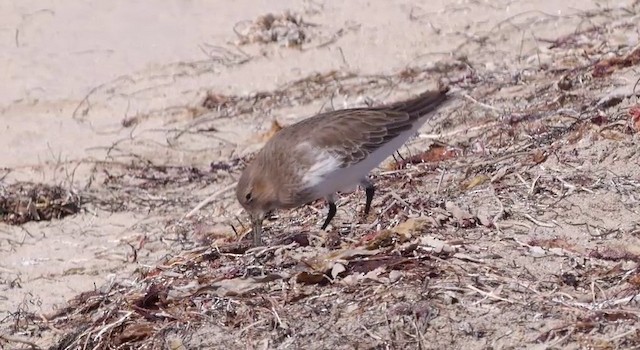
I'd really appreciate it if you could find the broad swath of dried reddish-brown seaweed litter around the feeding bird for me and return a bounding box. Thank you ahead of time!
[2,3,640,349]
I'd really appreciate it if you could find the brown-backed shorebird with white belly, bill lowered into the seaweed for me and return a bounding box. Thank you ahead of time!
[236,87,452,245]
